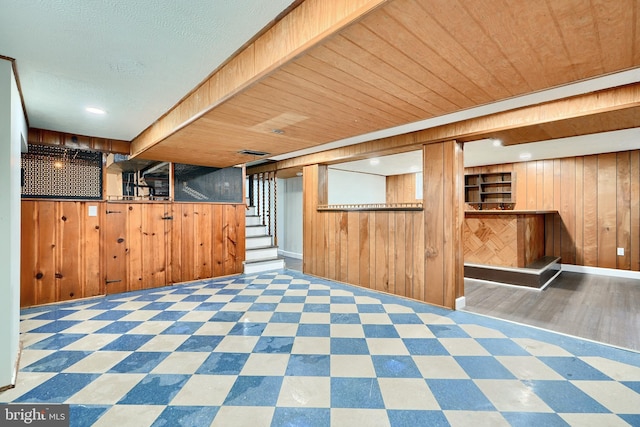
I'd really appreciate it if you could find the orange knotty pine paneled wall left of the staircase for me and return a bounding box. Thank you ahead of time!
[21,200,245,307]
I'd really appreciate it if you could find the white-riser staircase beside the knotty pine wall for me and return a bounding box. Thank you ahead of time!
[244,206,285,274]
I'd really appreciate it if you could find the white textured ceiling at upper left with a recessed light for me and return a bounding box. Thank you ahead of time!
[0,0,293,140]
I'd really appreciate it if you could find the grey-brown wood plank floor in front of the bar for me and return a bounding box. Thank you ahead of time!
[464,272,640,351]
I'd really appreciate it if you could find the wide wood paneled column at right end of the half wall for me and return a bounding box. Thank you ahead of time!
[423,141,464,309]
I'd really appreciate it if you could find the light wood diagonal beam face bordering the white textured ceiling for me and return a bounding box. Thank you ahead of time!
[131,0,388,160]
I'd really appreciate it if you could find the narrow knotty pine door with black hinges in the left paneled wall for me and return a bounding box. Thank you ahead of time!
[104,203,128,294]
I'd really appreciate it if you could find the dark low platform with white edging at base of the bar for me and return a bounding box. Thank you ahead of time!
[464,257,561,290]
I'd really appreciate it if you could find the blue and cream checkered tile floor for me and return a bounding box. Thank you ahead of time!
[0,270,640,427]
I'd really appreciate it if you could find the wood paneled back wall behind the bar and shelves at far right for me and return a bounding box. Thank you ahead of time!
[467,150,640,271]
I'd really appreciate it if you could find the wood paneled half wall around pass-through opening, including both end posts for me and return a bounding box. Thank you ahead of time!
[303,141,463,308]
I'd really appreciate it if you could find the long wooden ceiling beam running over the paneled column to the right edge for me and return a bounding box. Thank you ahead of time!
[270,83,640,172]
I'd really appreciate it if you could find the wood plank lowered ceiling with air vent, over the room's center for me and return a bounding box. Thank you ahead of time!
[134,0,640,167]
